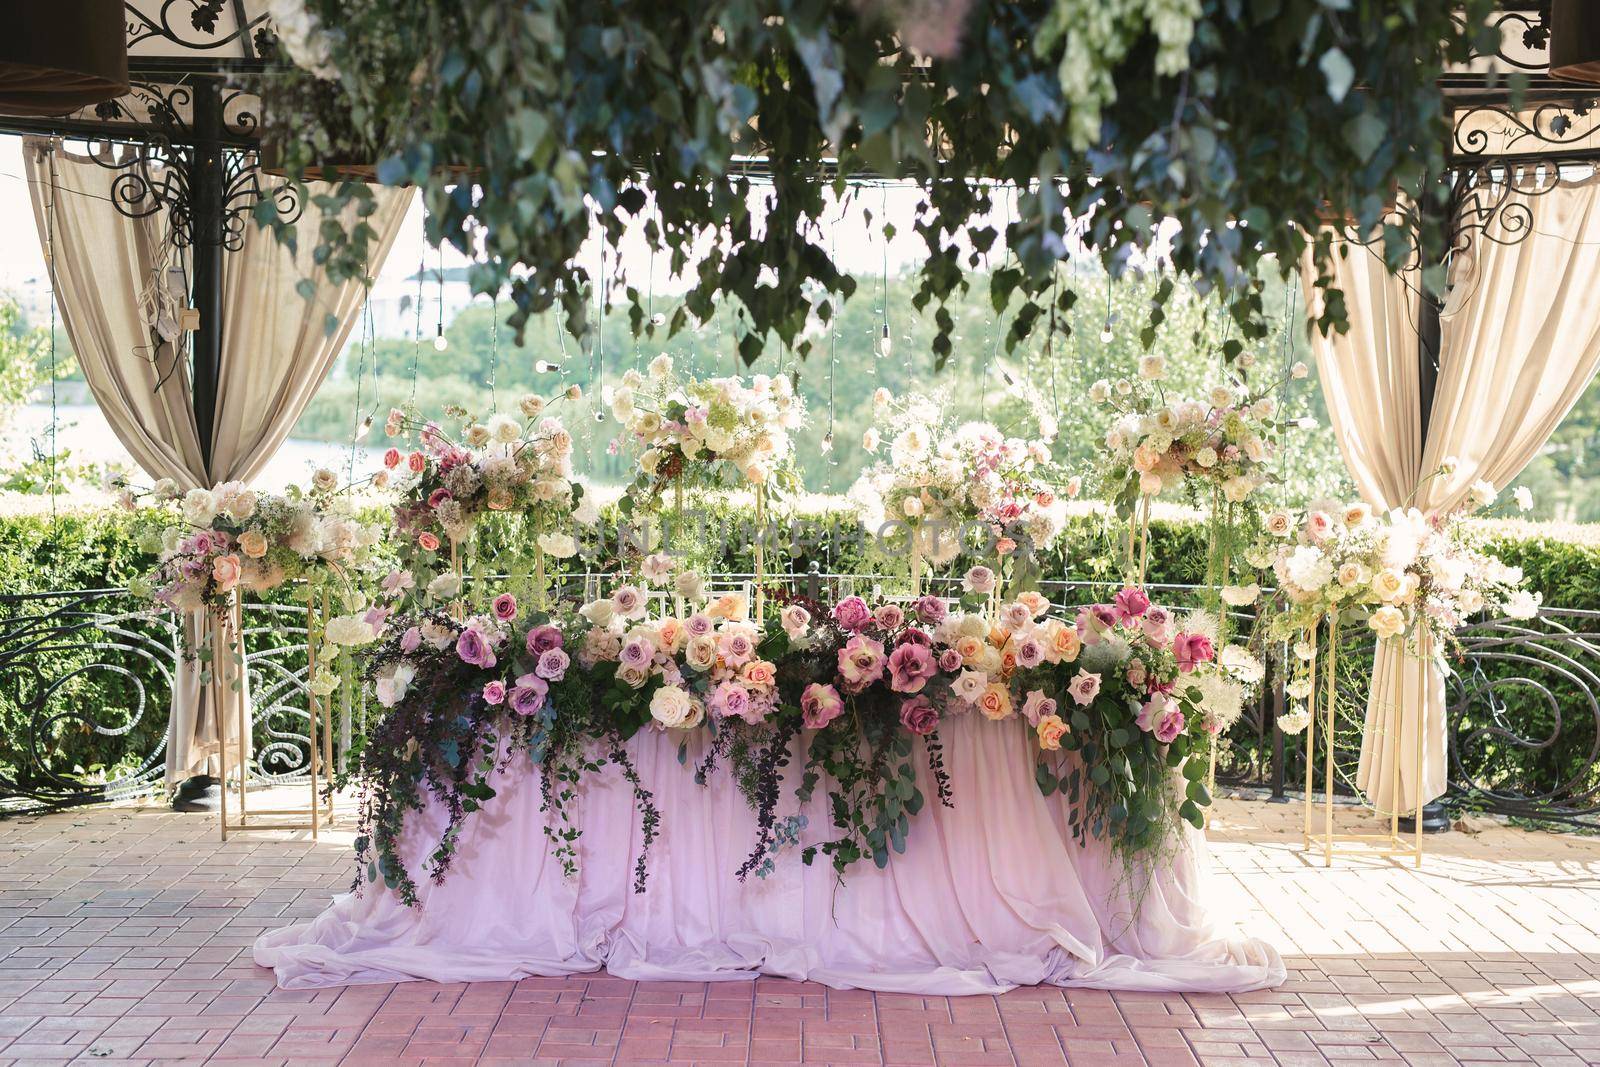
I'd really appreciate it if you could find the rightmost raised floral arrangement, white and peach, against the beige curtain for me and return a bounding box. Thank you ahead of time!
[1250,461,1539,733]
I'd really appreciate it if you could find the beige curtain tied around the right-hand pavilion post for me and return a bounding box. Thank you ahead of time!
[1302,179,1600,811]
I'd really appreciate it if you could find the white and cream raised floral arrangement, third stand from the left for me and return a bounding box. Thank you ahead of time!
[602,354,805,504]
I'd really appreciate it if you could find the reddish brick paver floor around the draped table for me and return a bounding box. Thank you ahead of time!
[0,800,1600,1067]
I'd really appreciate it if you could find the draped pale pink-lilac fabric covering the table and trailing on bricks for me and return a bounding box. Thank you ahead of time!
[254,715,1285,995]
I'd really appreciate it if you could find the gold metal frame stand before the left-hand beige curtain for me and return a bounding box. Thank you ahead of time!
[213,585,334,841]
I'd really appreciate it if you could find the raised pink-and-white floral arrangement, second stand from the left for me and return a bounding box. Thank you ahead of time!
[384,386,600,606]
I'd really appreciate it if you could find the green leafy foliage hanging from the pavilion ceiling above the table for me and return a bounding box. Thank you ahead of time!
[261,0,1491,363]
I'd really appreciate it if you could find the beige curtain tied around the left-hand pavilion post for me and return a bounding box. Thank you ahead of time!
[24,138,411,787]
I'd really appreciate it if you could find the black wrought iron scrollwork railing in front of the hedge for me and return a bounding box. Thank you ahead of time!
[0,568,1600,825]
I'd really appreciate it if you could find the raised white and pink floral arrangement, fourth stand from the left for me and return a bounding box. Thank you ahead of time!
[850,389,1078,593]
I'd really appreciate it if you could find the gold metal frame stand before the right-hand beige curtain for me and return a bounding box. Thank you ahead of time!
[1302,614,1426,867]
